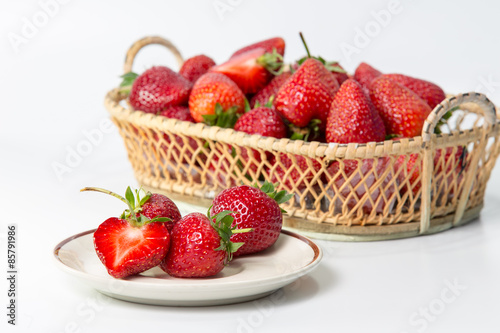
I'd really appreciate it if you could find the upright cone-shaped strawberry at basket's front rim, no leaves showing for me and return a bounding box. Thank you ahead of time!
[326,79,385,143]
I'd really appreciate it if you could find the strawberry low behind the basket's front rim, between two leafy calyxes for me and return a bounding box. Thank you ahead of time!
[234,106,287,173]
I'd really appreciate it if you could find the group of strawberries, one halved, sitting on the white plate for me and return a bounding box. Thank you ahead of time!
[82,183,291,278]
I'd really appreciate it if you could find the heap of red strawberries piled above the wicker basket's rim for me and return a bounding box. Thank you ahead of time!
[123,34,445,143]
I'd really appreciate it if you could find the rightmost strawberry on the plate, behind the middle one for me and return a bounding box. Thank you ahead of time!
[210,182,291,256]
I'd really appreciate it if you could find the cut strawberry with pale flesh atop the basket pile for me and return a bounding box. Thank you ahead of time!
[210,40,284,94]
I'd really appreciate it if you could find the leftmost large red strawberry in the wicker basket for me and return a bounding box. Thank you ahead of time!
[129,66,192,113]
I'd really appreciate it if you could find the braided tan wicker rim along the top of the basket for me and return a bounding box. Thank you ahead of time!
[105,88,500,159]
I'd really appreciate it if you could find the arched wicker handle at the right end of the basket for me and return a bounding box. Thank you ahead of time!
[420,92,497,234]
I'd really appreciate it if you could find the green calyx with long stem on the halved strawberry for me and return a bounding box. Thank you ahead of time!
[80,186,170,228]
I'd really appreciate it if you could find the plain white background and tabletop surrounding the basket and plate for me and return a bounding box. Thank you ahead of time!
[0,0,500,333]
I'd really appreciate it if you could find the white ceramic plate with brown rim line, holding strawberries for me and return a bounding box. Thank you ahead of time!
[54,230,322,306]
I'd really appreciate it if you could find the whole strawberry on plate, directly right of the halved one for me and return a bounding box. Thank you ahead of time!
[160,212,250,278]
